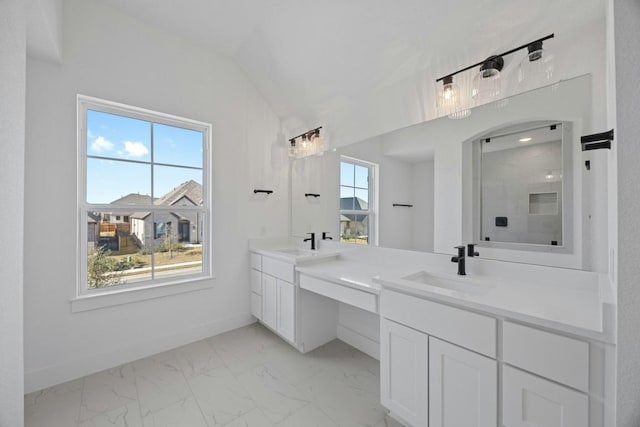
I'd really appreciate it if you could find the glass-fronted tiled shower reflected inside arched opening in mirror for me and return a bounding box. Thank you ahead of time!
[478,123,563,246]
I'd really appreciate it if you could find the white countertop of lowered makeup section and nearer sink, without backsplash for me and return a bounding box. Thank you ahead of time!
[296,259,614,343]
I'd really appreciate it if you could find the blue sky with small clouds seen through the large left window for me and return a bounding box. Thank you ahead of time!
[87,110,203,203]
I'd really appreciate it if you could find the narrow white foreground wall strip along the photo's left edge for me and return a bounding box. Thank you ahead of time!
[0,0,26,427]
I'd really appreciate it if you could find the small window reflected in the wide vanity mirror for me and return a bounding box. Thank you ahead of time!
[340,156,376,245]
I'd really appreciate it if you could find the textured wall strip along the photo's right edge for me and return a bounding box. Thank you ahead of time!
[614,0,640,427]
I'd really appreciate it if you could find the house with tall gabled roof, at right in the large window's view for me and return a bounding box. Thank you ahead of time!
[129,180,203,247]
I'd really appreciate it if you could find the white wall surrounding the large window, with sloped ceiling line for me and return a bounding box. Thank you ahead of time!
[23,0,288,391]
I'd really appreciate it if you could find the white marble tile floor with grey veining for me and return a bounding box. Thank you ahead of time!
[25,323,401,427]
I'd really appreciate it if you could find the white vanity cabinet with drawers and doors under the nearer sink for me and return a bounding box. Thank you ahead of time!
[380,288,600,427]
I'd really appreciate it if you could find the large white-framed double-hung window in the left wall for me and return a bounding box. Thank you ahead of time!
[78,95,211,294]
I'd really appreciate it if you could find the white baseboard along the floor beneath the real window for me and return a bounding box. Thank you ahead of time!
[24,313,256,394]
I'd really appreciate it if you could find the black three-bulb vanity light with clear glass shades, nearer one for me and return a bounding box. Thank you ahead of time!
[436,34,554,119]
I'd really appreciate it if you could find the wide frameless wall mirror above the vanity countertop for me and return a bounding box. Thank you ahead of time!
[291,75,593,269]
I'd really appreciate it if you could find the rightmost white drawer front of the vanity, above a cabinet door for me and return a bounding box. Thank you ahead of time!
[502,322,589,392]
